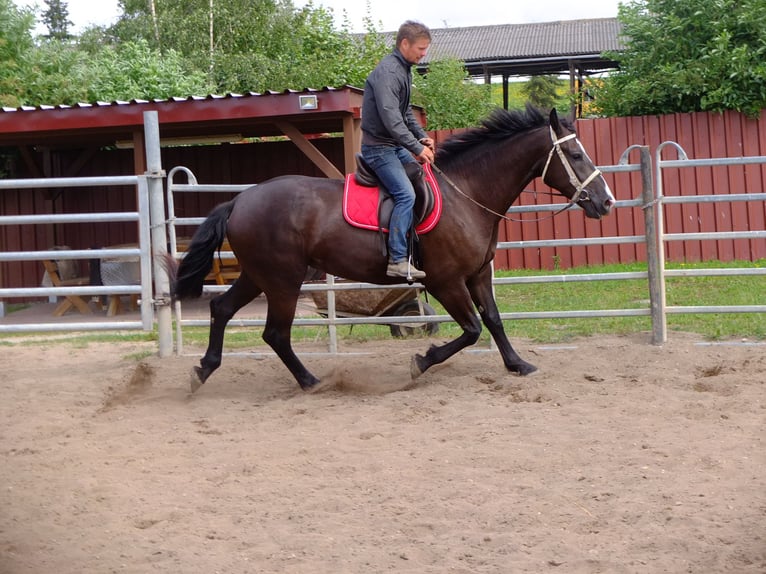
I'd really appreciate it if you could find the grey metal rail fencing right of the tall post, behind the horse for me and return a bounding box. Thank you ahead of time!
[168,142,766,352]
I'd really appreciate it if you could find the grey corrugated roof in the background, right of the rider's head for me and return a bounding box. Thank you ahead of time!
[396,18,624,76]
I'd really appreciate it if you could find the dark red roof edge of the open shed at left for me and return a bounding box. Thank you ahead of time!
[0,86,363,147]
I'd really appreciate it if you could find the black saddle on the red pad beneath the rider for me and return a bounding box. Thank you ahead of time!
[354,153,437,232]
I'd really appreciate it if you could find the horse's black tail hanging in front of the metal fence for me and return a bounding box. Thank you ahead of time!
[165,199,235,300]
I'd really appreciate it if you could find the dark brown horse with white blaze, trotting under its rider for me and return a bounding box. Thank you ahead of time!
[167,105,615,392]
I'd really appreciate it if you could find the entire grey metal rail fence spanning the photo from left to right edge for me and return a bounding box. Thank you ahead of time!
[0,141,766,356]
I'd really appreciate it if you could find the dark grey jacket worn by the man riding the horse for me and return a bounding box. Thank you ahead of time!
[362,49,428,155]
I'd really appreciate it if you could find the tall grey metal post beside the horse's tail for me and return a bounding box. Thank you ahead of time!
[144,111,173,357]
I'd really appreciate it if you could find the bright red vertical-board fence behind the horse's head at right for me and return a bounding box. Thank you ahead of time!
[486,112,766,269]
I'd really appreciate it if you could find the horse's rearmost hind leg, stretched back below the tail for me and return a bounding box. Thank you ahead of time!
[191,273,261,392]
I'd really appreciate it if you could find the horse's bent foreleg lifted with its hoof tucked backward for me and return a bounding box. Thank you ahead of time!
[410,285,481,379]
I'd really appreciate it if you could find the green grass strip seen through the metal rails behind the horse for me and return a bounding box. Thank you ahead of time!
[178,260,766,350]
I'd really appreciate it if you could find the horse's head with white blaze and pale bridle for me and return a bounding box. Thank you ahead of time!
[542,108,615,219]
